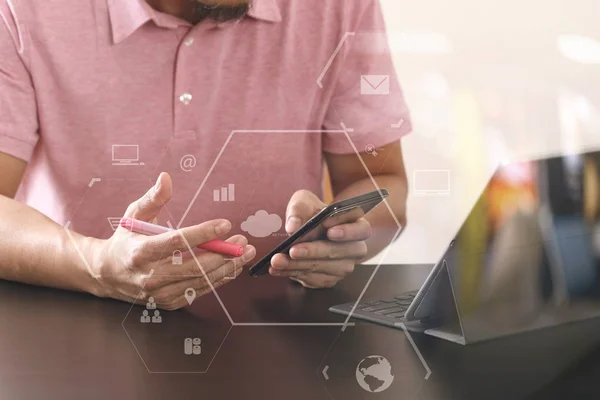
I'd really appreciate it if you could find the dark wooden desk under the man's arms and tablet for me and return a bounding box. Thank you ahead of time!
[0,265,600,400]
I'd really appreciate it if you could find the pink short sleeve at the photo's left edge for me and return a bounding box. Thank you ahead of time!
[0,0,39,162]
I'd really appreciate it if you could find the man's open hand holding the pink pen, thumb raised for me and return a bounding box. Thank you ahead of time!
[83,173,256,310]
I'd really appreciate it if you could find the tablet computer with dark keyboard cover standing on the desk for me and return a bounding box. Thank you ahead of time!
[329,151,600,344]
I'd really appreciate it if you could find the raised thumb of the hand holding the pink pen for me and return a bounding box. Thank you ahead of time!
[124,172,173,221]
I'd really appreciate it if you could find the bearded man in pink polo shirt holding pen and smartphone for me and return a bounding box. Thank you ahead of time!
[0,0,411,309]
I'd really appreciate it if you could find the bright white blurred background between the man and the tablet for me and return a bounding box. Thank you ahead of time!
[364,0,600,264]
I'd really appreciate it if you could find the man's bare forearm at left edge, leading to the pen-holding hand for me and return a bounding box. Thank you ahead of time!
[0,196,95,292]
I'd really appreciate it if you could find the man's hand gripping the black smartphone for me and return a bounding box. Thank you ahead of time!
[269,190,371,289]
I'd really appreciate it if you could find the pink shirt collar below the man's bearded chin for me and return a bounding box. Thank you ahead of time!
[107,0,282,44]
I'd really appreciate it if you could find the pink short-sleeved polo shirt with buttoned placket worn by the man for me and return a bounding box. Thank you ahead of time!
[0,0,411,256]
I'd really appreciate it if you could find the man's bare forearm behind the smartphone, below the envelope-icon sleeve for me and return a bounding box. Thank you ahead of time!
[335,174,408,261]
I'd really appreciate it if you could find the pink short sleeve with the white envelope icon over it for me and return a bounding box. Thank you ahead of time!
[323,0,412,154]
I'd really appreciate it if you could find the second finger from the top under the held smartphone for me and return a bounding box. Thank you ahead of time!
[290,240,367,260]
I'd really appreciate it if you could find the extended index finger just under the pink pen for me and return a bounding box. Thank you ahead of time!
[145,219,231,254]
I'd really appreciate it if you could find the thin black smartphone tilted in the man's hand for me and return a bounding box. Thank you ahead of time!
[248,189,390,277]
